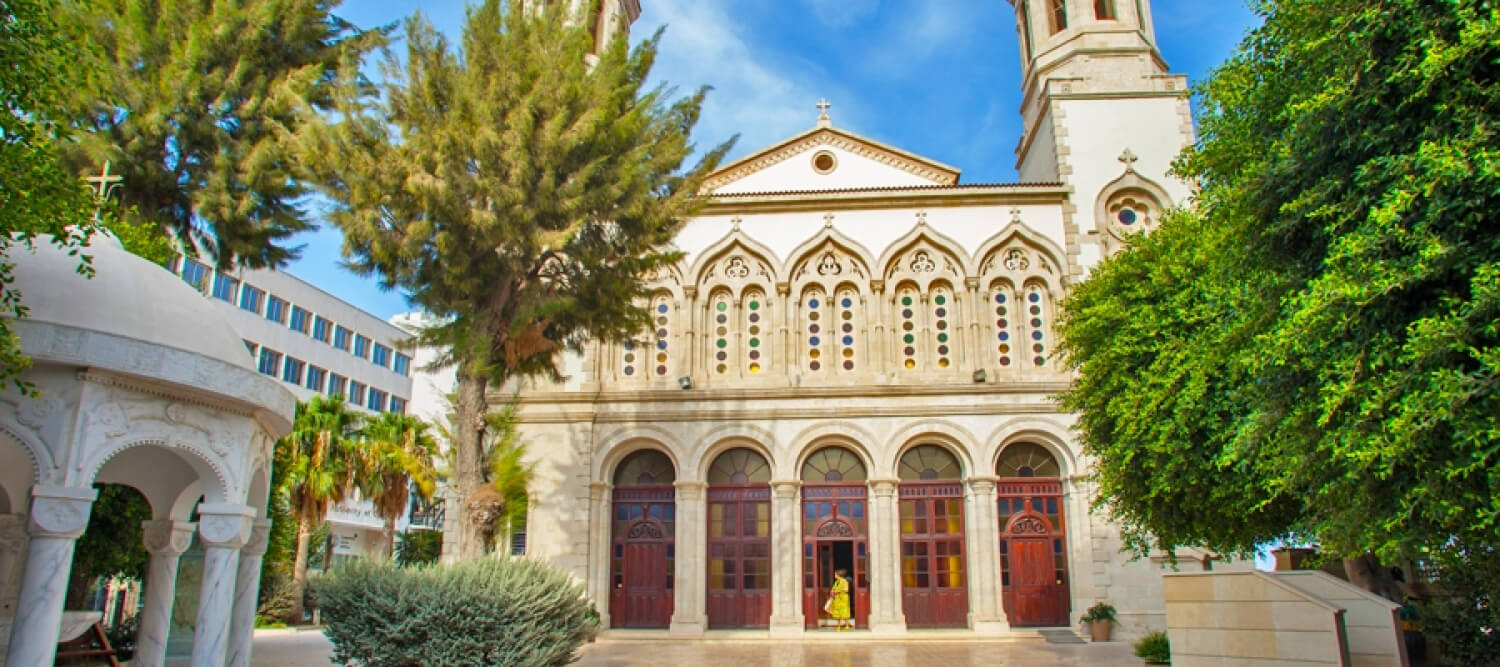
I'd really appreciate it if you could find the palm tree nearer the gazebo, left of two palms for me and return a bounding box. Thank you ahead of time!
[278,396,360,622]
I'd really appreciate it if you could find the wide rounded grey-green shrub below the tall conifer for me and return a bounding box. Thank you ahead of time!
[312,558,599,667]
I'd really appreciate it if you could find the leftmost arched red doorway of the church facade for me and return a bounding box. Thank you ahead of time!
[609,450,677,628]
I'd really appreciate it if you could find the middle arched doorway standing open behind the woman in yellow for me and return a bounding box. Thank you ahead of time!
[803,447,870,628]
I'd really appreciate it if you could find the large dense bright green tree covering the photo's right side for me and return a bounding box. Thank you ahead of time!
[1062,0,1500,596]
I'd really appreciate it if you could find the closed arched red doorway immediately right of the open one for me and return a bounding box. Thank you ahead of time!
[897,445,969,628]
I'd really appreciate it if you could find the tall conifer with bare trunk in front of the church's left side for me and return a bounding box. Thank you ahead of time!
[303,0,729,558]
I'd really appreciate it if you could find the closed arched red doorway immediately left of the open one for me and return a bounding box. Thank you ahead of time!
[708,447,771,628]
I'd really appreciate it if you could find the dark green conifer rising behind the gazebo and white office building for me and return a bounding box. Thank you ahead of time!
[50,0,386,267]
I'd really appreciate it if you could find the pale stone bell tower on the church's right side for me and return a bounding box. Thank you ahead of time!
[1010,0,1194,267]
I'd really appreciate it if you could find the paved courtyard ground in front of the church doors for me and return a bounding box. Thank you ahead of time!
[254,631,1140,667]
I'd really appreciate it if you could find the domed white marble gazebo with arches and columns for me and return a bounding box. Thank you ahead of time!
[0,230,296,667]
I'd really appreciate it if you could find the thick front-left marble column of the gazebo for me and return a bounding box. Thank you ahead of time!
[6,484,99,667]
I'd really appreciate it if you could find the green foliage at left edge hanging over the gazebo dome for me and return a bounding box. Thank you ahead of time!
[0,0,93,391]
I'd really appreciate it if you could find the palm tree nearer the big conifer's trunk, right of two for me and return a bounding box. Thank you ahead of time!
[359,412,438,558]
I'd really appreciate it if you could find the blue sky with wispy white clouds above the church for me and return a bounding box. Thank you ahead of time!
[288,0,1257,318]
